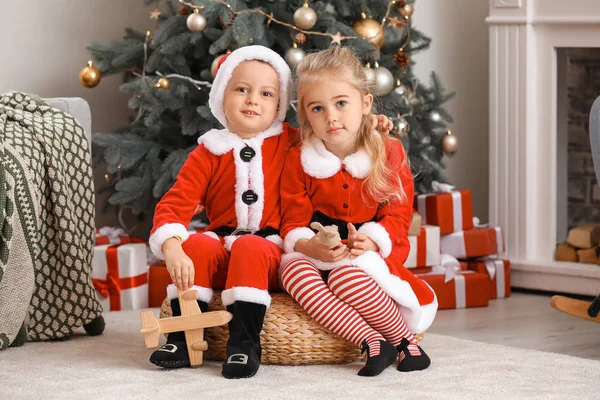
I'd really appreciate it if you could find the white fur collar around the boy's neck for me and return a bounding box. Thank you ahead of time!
[198,121,283,156]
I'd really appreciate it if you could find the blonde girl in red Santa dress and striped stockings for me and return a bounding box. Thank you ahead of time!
[280,47,437,376]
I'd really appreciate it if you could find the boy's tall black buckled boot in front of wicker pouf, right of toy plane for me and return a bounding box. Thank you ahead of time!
[221,300,267,379]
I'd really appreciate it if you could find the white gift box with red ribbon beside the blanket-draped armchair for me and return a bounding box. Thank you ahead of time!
[92,243,148,311]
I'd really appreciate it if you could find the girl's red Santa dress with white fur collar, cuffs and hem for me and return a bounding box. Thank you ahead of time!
[281,137,437,333]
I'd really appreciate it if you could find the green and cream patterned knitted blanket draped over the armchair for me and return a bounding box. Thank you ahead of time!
[0,92,102,349]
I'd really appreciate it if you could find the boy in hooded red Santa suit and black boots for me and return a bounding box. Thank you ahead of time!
[150,46,390,378]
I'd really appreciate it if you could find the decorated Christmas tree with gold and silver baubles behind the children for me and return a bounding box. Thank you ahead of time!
[80,0,457,220]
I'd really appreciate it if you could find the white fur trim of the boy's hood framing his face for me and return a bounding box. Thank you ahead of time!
[208,46,293,127]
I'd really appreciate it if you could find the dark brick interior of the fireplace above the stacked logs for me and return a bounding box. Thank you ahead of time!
[566,48,600,229]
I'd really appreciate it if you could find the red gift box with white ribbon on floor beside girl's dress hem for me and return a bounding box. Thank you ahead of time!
[417,271,489,310]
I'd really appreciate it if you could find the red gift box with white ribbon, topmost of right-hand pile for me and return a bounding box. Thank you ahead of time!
[415,190,473,235]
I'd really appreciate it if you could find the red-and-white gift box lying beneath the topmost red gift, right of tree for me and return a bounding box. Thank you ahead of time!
[440,227,504,258]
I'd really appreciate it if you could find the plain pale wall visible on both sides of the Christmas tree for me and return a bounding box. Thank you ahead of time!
[0,0,488,233]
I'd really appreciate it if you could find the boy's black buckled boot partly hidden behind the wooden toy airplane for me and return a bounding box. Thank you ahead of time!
[150,299,208,368]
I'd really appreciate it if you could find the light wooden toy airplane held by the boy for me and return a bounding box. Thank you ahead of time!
[140,290,232,366]
